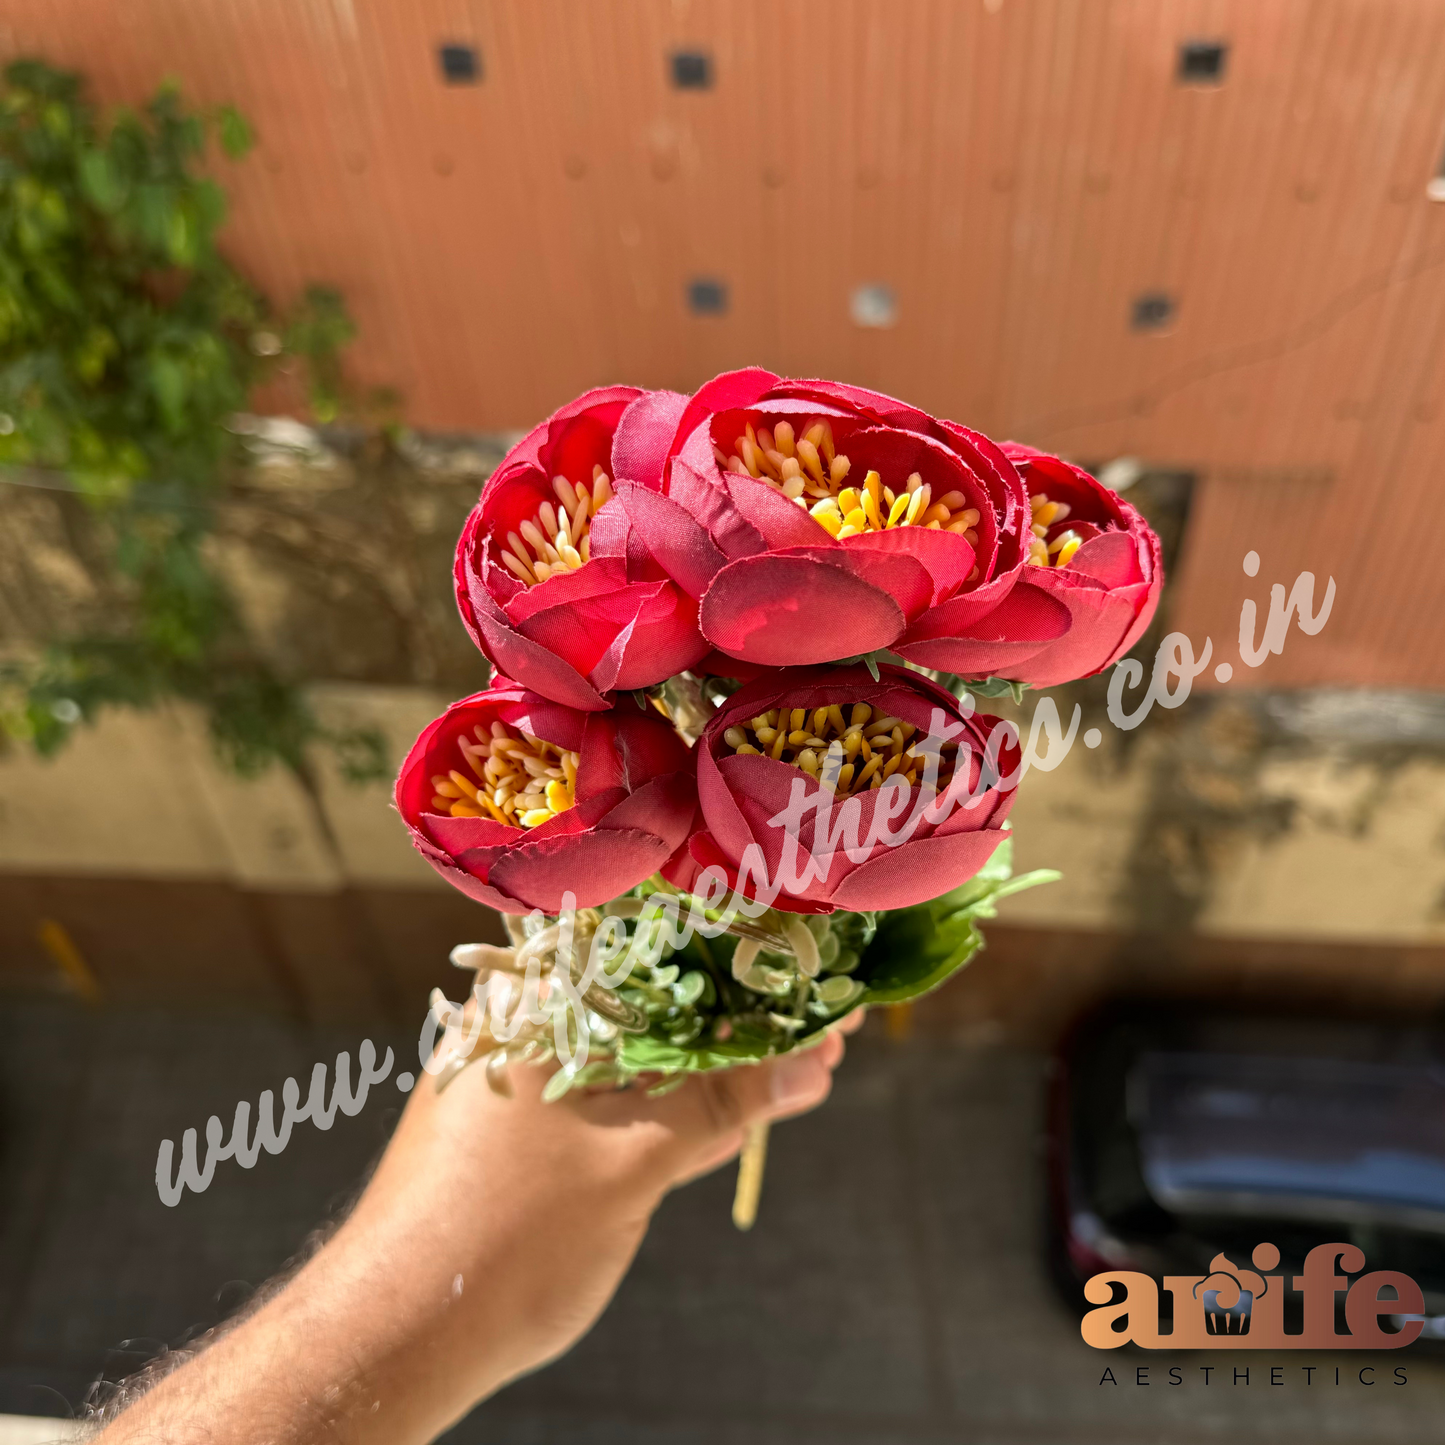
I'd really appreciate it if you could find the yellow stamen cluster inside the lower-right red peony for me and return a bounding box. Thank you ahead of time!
[723,702,958,796]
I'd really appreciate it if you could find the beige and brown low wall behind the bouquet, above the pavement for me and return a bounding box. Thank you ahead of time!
[0,685,1445,1016]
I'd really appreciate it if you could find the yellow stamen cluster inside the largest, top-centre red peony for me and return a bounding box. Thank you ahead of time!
[712,420,978,560]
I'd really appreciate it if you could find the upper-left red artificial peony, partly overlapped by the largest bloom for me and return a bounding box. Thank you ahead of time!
[454,386,708,711]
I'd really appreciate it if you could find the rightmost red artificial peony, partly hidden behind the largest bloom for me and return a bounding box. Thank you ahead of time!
[897,442,1163,688]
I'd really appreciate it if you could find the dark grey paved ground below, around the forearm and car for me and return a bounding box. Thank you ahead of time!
[0,998,1445,1445]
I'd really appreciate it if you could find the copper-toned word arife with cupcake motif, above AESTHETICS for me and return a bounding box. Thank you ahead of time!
[1079,1244,1425,1350]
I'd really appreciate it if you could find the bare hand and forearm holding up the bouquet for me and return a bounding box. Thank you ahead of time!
[104,1012,863,1445]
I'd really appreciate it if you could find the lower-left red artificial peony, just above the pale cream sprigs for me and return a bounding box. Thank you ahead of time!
[396,679,696,913]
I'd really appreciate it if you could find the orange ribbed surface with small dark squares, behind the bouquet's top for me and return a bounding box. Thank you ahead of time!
[8,0,1445,686]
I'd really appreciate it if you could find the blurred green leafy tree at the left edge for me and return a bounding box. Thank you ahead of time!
[0,59,384,783]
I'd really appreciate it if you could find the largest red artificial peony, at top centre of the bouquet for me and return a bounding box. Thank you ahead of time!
[613,368,1046,666]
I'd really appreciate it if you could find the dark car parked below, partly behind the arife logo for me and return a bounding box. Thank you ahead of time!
[1049,1000,1445,1341]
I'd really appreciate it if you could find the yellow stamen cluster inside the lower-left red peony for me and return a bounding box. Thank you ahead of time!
[432,723,577,828]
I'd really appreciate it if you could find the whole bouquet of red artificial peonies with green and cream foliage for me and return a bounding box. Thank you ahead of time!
[396,368,1163,1222]
